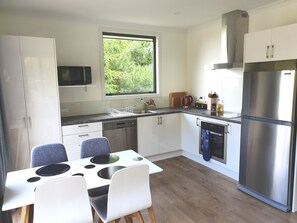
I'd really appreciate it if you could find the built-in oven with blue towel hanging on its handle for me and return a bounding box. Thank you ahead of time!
[199,120,228,163]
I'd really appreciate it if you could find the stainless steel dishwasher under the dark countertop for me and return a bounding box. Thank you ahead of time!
[102,118,137,152]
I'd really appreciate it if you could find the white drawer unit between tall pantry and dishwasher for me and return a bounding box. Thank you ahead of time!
[62,122,102,160]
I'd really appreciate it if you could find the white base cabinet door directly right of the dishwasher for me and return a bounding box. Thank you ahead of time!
[137,116,159,156]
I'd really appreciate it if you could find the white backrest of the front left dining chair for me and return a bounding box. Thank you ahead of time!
[33,176,93,223]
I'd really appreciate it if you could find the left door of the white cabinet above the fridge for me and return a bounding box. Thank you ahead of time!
[244,30,271,63]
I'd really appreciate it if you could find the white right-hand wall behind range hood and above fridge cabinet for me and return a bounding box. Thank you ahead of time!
[187,0,297,112]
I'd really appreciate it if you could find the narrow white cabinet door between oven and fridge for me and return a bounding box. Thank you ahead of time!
[226,122,241,173]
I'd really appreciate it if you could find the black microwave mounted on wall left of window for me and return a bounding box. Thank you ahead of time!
[58,66,92,86]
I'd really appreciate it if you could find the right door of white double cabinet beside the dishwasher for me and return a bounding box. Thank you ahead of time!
[159,113,181,153]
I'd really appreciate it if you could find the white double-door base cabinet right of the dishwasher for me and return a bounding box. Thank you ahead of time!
[137,113,181,156]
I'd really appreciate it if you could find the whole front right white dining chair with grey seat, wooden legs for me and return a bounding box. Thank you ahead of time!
[91,164,155,223]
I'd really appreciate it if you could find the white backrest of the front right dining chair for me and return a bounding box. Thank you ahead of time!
[106,164,152,222]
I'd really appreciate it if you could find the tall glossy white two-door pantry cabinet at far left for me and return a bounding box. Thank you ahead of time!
[0,36,62,171]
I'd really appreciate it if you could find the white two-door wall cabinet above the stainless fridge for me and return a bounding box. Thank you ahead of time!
[244,24,297,63]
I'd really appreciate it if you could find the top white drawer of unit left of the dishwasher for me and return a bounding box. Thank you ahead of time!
[62,122,102,136]
